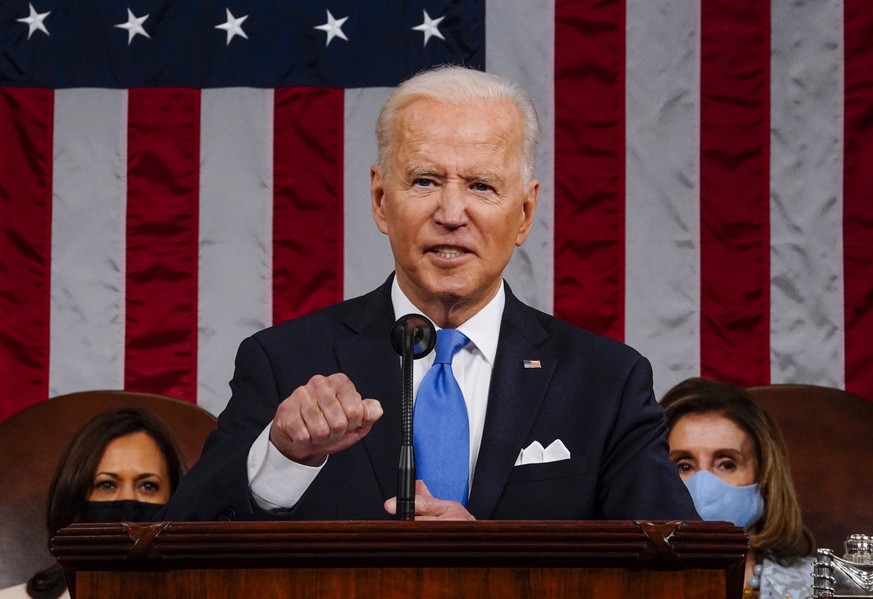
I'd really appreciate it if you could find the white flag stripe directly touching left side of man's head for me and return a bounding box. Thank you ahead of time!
[343,88,394,298]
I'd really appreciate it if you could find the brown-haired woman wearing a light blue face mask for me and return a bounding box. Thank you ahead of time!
[661,378,815,599]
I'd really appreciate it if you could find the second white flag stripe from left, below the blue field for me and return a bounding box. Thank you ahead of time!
[197,88,273,413]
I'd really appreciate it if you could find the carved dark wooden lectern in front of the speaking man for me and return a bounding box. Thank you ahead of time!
[51,521,748,599]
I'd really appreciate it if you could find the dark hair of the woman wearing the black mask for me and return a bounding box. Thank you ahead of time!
[27,408,185,599]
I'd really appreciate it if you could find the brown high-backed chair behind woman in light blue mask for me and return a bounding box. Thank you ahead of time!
[749,385,873,555]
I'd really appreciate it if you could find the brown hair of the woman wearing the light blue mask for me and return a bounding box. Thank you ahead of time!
[661,377,815,559]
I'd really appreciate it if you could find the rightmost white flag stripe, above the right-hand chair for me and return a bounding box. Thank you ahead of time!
[770,0,845,387]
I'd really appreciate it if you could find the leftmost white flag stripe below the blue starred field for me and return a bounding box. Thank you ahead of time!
[49,89,127,397]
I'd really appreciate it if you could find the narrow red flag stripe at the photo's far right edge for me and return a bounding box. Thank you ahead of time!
[843,0,873,399]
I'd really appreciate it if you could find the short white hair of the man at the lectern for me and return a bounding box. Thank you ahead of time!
[376,65,540,183]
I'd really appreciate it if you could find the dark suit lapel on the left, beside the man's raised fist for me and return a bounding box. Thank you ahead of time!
[335,278,400,497]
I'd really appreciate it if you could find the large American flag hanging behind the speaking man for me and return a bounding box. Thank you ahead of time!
[0,0,873,418]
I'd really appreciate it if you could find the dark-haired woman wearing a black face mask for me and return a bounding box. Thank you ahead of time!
[0,408,184,599]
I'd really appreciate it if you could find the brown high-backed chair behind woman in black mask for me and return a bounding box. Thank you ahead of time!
[0,391,216,588]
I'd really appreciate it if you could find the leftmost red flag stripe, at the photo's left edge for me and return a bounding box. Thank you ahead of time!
[0,88,54,420]
